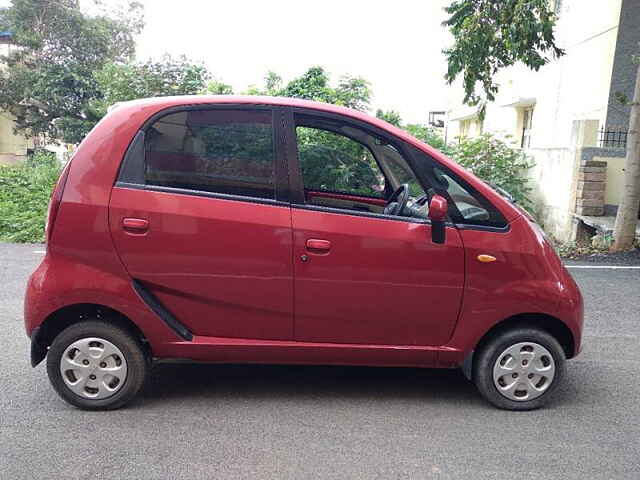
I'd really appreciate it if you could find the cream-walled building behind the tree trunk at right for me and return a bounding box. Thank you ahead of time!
[447,0,640,240]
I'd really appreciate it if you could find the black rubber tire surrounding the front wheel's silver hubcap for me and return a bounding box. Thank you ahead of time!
[473,327,566,410]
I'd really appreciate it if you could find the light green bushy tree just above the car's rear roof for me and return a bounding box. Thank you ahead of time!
[91,55,211,117]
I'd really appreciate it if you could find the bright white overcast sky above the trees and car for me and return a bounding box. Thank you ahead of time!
[0,0,451,122]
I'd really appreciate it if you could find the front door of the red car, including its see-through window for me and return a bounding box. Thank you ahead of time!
[289,110,464,346]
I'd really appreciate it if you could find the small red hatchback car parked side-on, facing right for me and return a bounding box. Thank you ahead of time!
[25,96,583,410]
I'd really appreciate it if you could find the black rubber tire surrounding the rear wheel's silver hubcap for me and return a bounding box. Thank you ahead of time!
[47,320,149,410]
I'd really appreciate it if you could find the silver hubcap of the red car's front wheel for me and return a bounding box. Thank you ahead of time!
[493,342,556,402]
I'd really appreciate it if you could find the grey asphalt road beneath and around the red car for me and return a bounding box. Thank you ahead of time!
[0,244,640,480]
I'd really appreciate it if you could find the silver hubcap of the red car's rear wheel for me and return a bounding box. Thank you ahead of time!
[60,337,127,400]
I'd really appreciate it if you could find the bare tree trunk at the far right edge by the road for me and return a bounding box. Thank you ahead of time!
[611,58,640,251]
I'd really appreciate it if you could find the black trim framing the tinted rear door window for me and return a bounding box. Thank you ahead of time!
[115,103,290,206]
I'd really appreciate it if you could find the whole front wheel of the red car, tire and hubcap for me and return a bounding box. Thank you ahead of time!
[473,327,566,410]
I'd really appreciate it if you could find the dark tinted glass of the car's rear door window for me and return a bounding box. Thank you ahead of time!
[145,109,275,199]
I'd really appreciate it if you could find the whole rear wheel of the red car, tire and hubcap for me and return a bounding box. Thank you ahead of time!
[47,320,149,410]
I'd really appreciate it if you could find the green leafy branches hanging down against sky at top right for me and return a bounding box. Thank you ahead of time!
[443,0,564,109]
